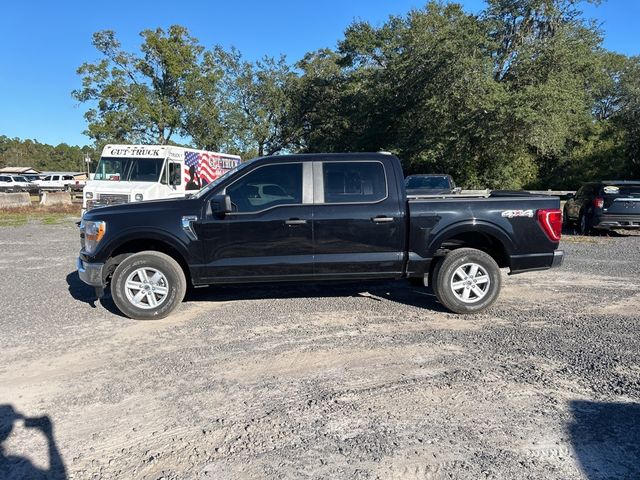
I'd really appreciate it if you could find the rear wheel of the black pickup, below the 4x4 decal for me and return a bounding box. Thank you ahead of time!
[433,248,502,314]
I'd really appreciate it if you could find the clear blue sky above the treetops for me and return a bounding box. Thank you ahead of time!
[0,0,640,145]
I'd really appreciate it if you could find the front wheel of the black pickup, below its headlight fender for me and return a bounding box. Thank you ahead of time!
[111,251,187,320]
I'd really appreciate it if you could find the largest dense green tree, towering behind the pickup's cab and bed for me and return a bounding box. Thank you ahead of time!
[294,0,615,188]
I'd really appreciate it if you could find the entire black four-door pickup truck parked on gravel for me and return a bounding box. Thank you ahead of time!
[78,153,563,319]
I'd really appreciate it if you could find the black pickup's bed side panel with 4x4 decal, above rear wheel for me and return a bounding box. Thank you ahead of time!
[407,192,560,275]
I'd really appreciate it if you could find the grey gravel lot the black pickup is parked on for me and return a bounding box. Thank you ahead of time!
[0,221,640,480]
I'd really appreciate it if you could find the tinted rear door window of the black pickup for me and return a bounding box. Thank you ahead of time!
[322,161,387,203]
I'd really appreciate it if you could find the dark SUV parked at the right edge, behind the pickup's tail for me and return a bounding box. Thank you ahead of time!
[562,180,640,235]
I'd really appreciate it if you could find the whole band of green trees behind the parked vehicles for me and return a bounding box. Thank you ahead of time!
[0,0,640,189]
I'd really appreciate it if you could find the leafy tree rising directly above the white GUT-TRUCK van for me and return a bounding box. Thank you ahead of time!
[73,25,222,147]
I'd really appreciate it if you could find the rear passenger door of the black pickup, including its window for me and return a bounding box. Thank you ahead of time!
[313,160,405,278]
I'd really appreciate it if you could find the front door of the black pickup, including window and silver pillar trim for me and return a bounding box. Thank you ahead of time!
[196,161,313,283]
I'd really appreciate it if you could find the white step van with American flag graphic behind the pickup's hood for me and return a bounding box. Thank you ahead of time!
[82,145,241,210]
